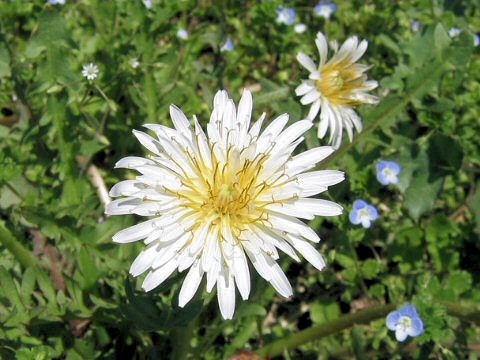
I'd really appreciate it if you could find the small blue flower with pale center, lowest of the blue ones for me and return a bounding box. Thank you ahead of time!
[387,304,424,341]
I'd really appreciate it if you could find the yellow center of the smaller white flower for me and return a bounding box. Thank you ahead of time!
[316,58,366,107]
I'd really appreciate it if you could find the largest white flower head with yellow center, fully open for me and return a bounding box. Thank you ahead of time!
[105,90,344,319]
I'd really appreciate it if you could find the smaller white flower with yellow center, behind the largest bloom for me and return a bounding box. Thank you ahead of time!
[295,32,378,148]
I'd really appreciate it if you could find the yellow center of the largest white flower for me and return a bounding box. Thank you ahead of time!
[170,142,282,232]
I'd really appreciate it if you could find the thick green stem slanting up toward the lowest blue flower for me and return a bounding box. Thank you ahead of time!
[257,304,396,358]
